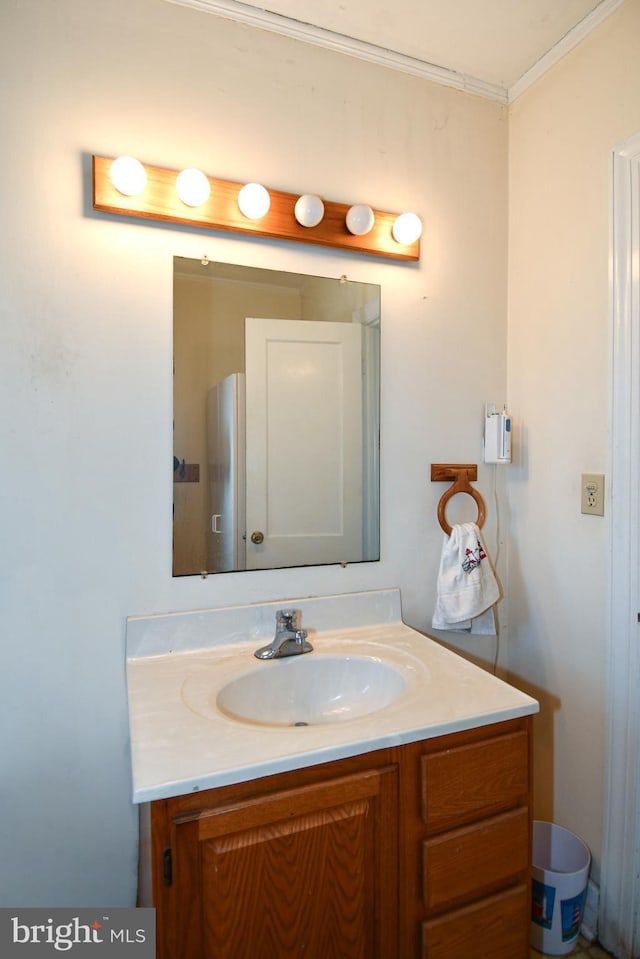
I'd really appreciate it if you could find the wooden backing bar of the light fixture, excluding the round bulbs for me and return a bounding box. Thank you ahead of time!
[93,156,420,261]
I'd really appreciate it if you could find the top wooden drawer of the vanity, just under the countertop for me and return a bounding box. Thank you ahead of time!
[420,730,529,835]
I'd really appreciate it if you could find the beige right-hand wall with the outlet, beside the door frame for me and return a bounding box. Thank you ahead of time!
[508,0,640,878]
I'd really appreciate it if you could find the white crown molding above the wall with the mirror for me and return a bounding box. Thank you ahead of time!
[166,0,508,103]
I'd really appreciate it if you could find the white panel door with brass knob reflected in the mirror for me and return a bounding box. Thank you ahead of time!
[245,317,362,569]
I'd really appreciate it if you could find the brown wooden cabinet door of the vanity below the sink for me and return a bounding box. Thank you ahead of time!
[162,766,397,959]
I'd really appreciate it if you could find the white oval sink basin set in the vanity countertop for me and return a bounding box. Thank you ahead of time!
[216,653,405,726]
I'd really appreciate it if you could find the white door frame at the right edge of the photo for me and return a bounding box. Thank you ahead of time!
[599,134,640,959]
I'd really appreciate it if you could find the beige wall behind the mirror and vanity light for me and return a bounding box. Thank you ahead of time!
[0,0,507,906]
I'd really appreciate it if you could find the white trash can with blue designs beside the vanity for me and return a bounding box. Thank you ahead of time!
[531,821,591,956]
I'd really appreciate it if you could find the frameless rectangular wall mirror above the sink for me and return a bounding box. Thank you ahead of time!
[173,257,380,576]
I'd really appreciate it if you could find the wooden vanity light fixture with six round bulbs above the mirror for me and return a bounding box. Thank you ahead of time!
[93,156,420,261]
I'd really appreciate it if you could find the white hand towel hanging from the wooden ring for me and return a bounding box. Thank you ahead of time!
[431,523,500,636]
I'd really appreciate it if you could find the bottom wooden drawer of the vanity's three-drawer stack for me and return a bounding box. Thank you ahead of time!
[422,884,531,959]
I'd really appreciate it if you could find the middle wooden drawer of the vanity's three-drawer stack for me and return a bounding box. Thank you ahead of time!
[422,807,529,913]
